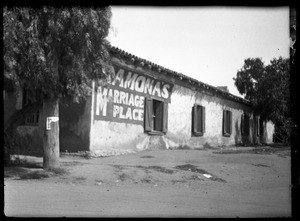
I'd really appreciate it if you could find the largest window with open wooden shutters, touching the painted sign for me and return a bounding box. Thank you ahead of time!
[144,98,168,134]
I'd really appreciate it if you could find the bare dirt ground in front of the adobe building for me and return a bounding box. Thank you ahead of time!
[4,147,291,218]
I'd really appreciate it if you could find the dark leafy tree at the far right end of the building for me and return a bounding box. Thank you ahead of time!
[233,57,292,142]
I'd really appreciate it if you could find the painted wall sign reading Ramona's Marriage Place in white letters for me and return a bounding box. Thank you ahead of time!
[94,65,174,124]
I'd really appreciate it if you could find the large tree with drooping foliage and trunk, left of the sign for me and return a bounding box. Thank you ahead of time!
[3,7,112,169]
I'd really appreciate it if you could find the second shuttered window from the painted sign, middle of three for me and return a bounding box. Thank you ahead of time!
[192,104,205,136]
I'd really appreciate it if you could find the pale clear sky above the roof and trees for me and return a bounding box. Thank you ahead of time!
[108,6,290,97]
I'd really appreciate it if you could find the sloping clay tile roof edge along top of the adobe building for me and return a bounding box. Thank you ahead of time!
[110,46,252,106]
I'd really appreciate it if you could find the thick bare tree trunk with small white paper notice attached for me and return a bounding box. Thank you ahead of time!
[43,98,59,169]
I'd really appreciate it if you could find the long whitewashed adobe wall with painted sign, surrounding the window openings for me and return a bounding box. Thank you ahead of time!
[90,58,273,154]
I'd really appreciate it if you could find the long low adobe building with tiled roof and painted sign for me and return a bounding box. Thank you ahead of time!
[4,47,274,156]
